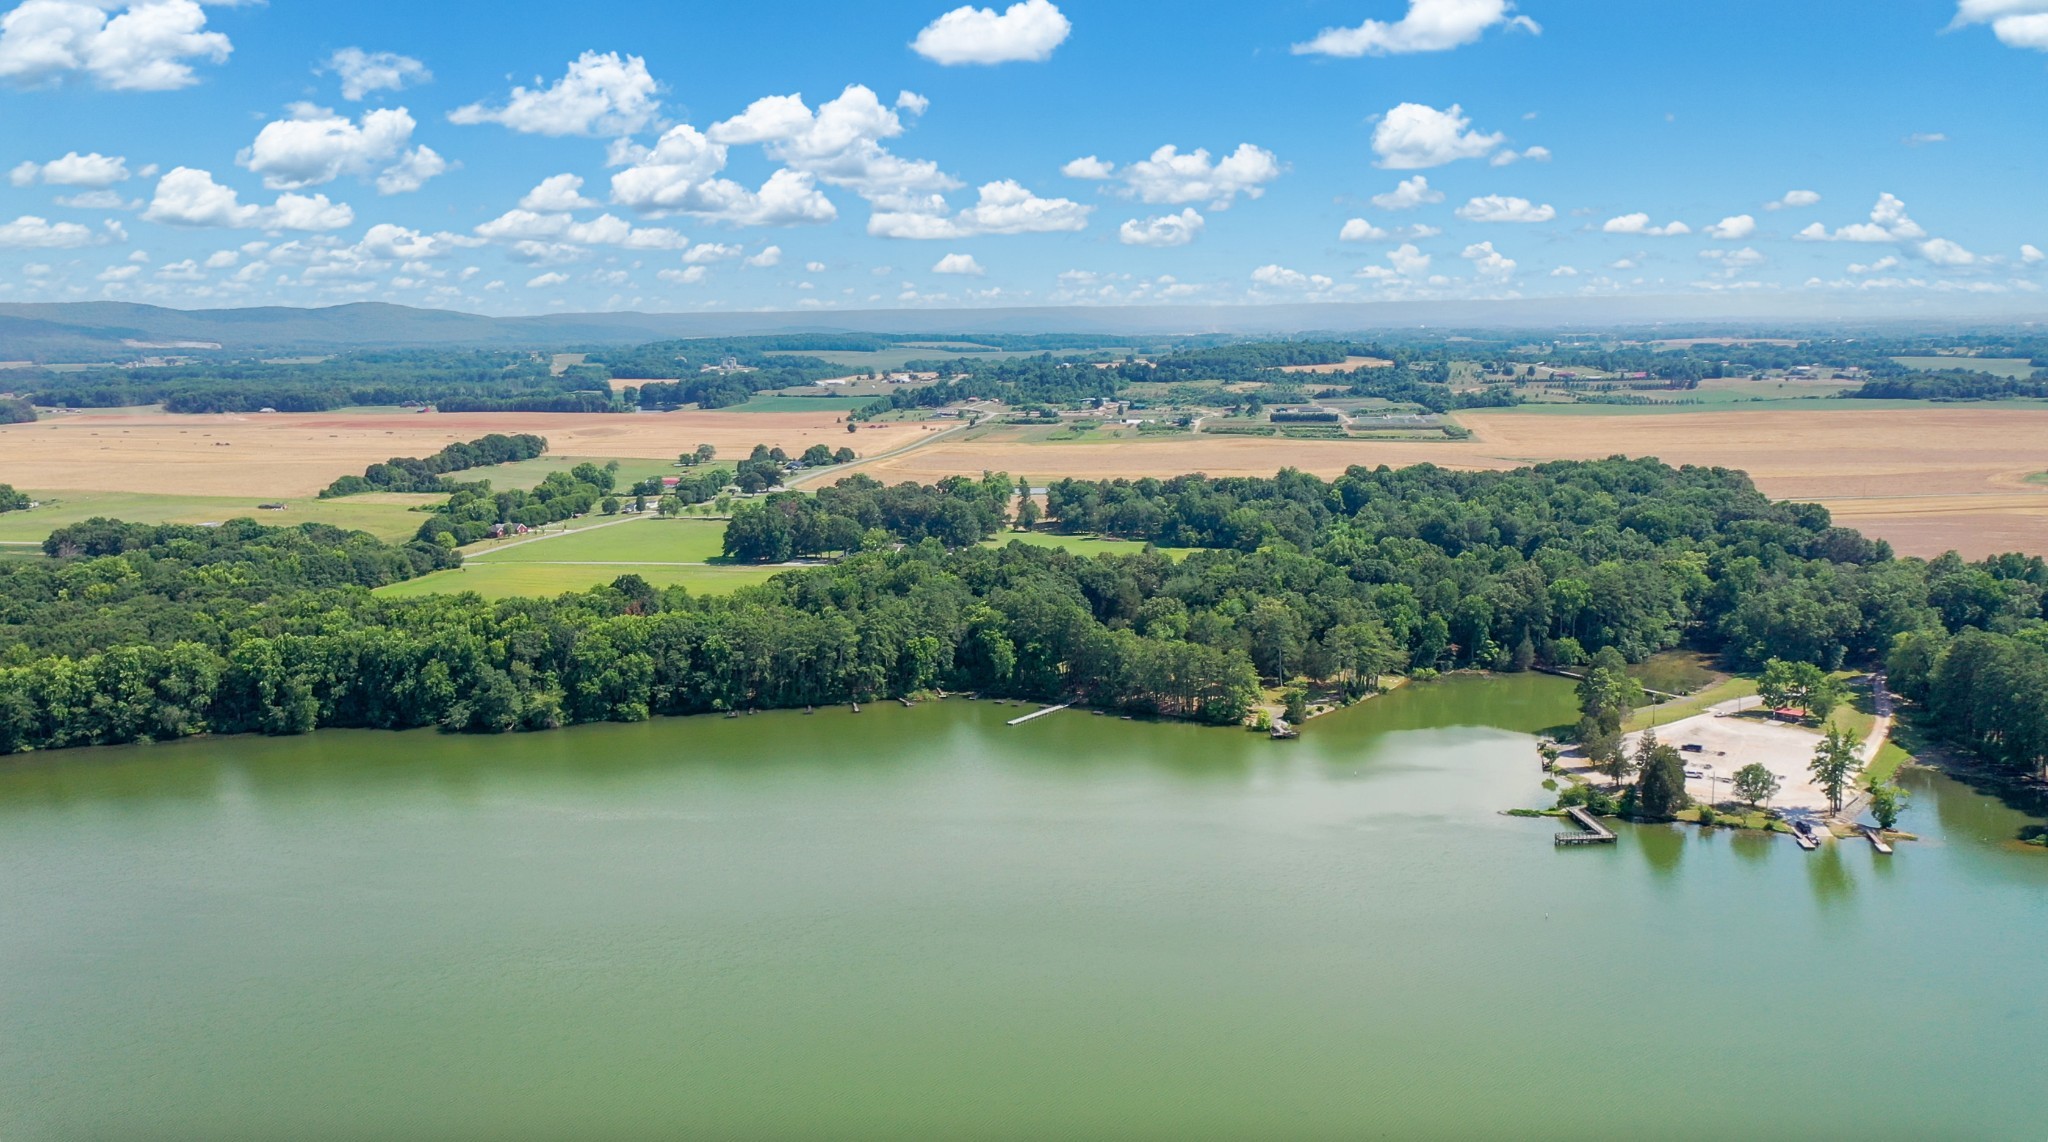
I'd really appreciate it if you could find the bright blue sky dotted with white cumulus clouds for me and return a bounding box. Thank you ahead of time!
[0,0,2048,315]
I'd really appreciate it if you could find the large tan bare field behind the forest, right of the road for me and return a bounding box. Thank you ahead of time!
[866,407,2048,557]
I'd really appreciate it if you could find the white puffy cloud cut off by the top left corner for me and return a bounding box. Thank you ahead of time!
[0,0,233,92]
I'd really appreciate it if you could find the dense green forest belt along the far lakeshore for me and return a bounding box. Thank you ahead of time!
[0,458,2048,794]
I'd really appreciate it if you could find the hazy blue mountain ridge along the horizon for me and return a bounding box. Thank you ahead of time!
[0,297,2048,362]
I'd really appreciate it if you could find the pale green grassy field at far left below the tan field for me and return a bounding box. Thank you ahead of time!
[0,491,440,542]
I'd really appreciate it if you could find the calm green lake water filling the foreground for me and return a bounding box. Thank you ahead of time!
[0,677,2048,1142]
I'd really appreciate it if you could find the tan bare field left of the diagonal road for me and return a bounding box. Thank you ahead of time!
[0,411,921,497]
